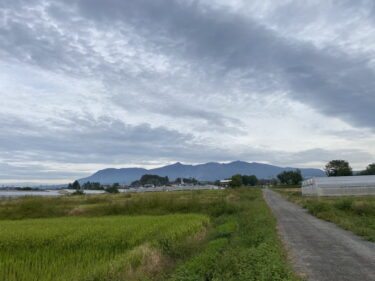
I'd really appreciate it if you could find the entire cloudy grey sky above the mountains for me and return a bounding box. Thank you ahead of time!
[0,0,375,184]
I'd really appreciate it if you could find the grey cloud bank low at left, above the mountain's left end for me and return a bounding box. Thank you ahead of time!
[0,116,198,163]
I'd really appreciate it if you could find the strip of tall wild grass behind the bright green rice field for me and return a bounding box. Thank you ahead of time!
[0,191,238,219]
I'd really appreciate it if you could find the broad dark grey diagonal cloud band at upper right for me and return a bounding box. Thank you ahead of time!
[69,0,375,128]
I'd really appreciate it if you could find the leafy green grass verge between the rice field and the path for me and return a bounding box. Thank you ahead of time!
[169,189,298,281]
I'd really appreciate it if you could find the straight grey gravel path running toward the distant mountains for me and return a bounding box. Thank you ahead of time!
[263,189,375,281]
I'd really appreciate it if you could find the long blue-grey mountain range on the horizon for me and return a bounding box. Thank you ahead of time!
[78,161,325,184]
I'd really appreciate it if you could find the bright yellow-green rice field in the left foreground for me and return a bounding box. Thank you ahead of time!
[0,215,208,281]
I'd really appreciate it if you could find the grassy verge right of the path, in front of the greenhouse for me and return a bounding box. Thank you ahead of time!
[275,189,375,242]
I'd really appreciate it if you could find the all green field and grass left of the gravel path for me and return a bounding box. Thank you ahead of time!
[0,188,296,281]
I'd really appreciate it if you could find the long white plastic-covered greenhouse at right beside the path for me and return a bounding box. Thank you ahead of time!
[302,176,375,196]
